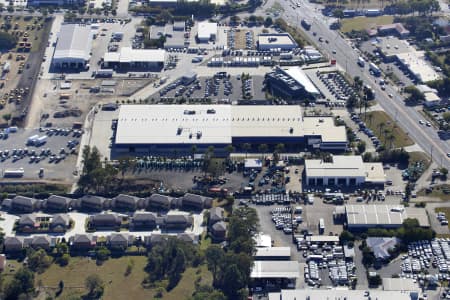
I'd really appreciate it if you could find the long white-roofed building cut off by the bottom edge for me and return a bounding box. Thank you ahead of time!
[269,288,420,300]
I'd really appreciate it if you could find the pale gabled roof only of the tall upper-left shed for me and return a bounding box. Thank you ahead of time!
[53,24,92,61]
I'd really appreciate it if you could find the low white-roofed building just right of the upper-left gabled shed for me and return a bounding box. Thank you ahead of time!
[103,47,166,70]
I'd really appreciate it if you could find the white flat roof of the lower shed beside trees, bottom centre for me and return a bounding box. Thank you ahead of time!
[250,260,300,278]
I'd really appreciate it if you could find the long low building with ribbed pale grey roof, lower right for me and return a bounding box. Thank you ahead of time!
[345,204,430,230]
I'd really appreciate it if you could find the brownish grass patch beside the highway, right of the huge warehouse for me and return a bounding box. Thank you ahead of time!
[363,111,414,148]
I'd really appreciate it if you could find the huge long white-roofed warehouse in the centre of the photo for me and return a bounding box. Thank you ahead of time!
[115,105,347,153]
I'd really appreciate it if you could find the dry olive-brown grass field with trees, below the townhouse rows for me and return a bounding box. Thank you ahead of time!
[36,256,212,300]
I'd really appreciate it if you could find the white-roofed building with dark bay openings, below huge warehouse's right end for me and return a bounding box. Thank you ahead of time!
[305,155,386,187]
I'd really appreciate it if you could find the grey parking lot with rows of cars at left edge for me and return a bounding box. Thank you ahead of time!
[0,128,81,182]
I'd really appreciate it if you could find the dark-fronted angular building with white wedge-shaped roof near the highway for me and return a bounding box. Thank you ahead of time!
[266,67,320,101]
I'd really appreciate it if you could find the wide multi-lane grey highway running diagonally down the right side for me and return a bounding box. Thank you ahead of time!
[266,0,450,168]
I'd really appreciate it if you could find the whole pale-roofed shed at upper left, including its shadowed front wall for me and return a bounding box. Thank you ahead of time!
[52,24,93,69]
